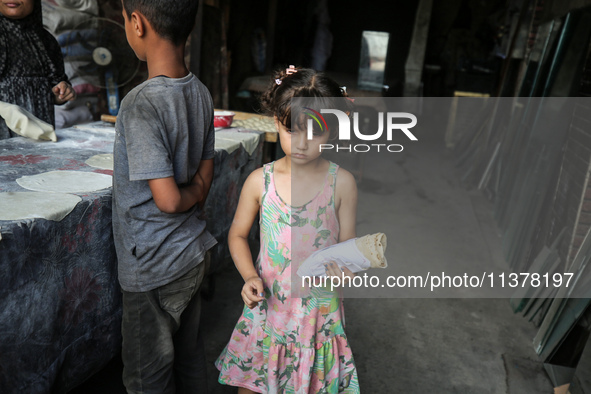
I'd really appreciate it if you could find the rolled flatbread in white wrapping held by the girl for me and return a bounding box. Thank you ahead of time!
[298,233,388,277]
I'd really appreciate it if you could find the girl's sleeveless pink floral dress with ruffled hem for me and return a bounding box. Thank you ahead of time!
[216,163,359,394]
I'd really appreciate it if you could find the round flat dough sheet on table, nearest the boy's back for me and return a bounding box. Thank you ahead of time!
[16,171,113,193]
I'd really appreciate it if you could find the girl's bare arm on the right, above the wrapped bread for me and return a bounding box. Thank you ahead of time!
[335,168,357,242]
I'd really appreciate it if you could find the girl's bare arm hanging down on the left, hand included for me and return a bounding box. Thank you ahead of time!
[228,168,264,308]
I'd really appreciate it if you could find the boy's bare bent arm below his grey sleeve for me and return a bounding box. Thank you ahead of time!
[148,159,213,213]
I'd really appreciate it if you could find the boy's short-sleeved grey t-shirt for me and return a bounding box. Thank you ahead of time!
[113,74,216,292]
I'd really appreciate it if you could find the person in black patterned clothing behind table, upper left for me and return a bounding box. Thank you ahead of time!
[0,0,75,140]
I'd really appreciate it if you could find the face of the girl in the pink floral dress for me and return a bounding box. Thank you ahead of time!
[275,117,330,164]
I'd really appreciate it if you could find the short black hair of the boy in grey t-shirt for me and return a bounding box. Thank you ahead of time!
[123,0,199,46]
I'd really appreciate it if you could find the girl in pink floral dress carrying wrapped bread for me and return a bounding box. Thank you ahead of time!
[216,69,359,393]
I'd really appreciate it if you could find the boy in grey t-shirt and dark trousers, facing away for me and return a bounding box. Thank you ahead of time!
[113,0,216,394]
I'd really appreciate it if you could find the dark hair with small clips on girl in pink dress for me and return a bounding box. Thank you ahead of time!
[261,68,353,137]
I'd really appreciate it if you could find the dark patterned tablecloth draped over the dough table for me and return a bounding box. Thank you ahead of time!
[0,122,263,393]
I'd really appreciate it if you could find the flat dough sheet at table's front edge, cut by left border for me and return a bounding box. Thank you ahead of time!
[0,192,82,221]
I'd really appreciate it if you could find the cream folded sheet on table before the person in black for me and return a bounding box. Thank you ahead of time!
[0,101,57,142]
